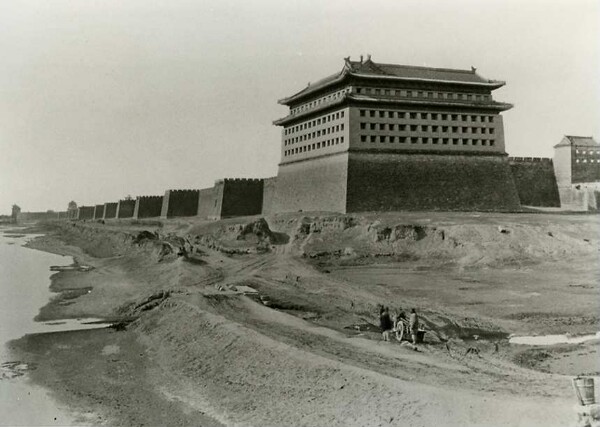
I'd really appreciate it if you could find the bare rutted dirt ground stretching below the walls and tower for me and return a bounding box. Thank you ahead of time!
[15,213,600,426]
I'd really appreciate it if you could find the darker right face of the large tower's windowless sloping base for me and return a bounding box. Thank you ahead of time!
[346,152,520,212]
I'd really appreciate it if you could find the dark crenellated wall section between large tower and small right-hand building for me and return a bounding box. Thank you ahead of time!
[509,157,560,207]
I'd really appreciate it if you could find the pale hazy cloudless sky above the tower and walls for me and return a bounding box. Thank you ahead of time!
[0,0,600,214]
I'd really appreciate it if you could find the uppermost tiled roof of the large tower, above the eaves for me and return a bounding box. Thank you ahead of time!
[279,58,504,104]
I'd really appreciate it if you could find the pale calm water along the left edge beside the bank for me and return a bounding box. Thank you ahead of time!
[0,227,106,426]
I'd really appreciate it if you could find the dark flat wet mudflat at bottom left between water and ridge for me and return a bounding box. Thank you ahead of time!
[12,329,220,427]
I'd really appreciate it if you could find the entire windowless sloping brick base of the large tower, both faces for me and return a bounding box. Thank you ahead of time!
[263,152,520,214]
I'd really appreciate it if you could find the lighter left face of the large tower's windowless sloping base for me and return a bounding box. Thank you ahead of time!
[263,153,348,213]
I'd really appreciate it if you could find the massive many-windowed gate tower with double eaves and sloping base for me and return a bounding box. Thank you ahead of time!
[268,57,519,213]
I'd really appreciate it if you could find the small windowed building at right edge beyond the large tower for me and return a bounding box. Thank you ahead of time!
[554,135,600,210]
